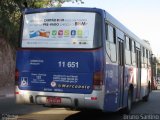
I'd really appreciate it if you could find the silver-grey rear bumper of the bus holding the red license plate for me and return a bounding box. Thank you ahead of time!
[16,87,104,110]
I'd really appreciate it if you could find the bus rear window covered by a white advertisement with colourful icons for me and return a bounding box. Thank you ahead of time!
[22,12,97,48]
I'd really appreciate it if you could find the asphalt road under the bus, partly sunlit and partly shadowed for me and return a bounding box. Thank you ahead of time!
[0,90,160,120]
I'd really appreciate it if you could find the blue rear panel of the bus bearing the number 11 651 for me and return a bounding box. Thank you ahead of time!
[16,50,103,94]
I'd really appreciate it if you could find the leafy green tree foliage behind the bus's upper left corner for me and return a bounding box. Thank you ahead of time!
[0,0,83,47]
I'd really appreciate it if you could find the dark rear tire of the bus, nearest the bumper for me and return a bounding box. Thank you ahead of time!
[124,90,132,114]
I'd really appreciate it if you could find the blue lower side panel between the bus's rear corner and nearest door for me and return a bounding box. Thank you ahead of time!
[104,64,119,111]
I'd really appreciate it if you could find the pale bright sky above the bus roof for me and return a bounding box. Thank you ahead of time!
[63,0,160,55]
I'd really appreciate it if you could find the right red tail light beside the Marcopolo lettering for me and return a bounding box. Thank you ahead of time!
[93,71,103,90]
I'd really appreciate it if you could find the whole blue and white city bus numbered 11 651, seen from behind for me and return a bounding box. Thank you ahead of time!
[15,7,152,113]
